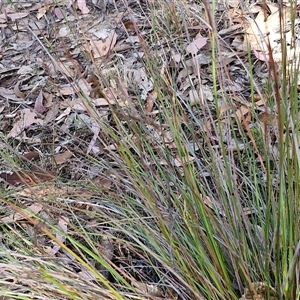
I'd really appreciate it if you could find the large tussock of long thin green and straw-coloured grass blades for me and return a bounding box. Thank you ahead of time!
[0,1,300,300]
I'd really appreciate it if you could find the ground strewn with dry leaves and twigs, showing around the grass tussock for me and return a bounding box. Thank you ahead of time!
[0,1,296,297]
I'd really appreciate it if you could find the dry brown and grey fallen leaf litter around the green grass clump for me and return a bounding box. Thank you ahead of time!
[0,0,292,299]
